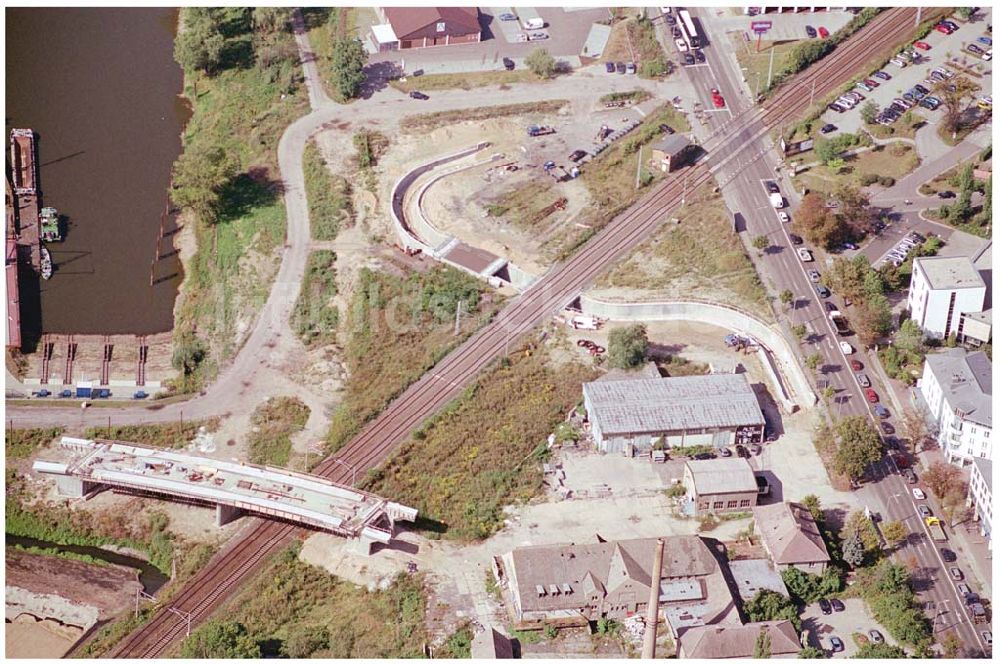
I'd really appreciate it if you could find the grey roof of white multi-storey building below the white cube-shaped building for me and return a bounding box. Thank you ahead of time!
[927,348,993,427]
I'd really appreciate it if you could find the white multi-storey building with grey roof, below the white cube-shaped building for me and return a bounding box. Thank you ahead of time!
[917,348,993,466]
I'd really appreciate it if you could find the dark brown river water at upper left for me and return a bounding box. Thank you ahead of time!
[5,8,190,339]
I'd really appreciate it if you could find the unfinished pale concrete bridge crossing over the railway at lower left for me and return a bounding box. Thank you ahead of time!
[33,436,417,553]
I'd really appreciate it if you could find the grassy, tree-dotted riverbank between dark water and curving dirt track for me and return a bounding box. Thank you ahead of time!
[173,8,308,391]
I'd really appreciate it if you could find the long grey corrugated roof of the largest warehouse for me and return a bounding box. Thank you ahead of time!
[583,374,764,435]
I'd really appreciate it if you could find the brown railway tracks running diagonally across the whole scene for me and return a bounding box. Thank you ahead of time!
[111,8,915,658]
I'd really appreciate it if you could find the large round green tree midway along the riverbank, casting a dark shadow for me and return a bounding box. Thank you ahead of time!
[170,141,239,222]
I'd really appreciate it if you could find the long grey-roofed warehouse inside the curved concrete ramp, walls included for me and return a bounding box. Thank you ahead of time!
[583,374,764,456]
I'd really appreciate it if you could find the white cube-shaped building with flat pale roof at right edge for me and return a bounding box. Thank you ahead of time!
[907,256,989,343]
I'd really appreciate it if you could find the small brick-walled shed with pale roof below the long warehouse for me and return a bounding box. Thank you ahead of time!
[684,457,758,515]
